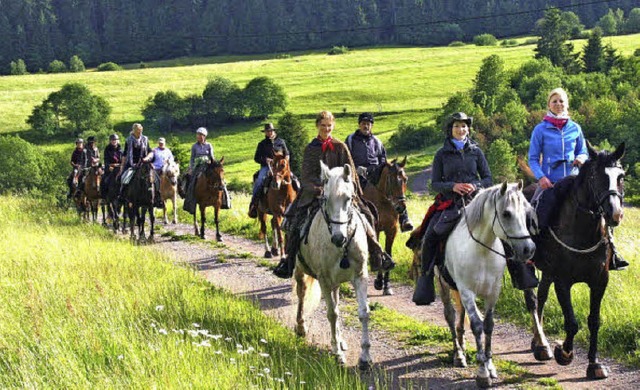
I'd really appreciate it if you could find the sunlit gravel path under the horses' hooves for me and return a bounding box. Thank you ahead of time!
[155,224,640,389]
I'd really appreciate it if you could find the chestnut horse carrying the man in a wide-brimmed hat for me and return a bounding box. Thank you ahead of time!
[257,154,296,259]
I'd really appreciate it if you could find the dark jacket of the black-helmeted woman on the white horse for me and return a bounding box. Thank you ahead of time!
[431,138,493,200]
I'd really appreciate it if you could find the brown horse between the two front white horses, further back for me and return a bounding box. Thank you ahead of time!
[363,157,407,295]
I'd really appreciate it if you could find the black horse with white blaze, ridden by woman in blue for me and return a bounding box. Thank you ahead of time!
[524,142,625,380]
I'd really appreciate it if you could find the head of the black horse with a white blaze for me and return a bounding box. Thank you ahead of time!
[576,142,625,226]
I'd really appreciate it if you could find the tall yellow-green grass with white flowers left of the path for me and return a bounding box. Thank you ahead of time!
[0,197,365,389]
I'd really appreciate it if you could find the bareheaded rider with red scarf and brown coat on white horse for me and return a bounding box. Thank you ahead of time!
[274,111,395,278]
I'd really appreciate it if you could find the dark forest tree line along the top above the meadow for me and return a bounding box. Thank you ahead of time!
[0,0,634,74]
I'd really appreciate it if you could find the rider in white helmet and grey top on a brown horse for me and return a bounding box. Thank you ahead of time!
[182,127,231,214]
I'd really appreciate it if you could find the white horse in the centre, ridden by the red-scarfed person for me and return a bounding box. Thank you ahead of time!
[295,162,373,370]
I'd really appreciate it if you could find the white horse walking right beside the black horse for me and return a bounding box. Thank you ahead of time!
[438,182,535,387]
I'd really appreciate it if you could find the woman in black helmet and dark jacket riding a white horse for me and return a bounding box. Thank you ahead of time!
[407,112,492,305]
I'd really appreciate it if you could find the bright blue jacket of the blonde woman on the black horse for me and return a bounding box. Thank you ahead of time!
[529,119,589,183]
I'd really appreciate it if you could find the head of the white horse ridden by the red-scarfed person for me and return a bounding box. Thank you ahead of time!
[320,161,355,247]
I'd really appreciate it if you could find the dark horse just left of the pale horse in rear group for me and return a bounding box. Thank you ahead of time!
[126,162,159,242]
